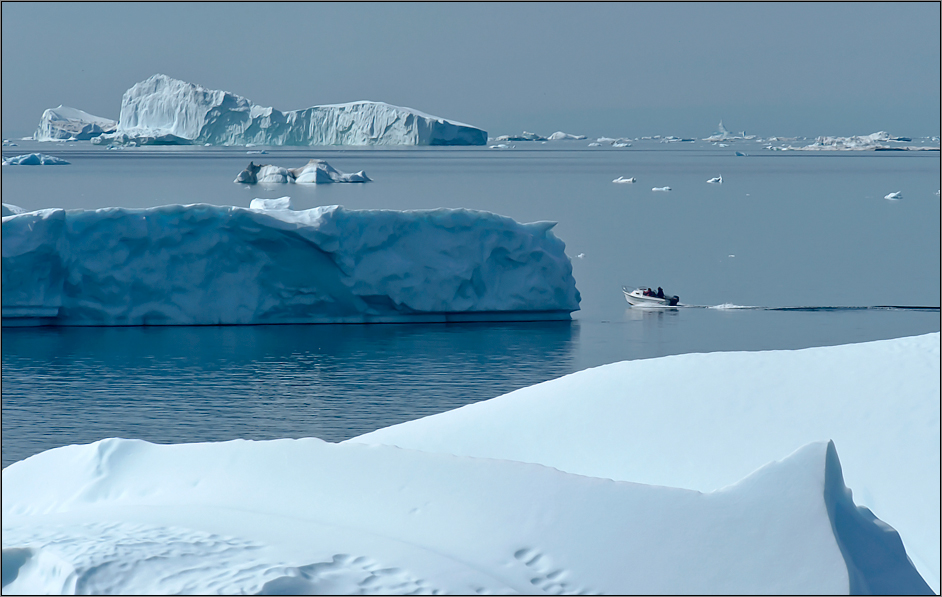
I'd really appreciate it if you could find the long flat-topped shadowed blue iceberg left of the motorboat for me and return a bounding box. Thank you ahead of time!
[2,204,580,325]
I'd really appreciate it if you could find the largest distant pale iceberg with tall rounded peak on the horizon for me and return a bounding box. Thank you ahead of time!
[92,75,487,145]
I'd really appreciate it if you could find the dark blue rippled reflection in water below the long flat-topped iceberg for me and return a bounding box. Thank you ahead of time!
[2,322,579,466]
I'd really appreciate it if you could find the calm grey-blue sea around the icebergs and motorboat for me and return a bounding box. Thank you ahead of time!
[2,141,940,466]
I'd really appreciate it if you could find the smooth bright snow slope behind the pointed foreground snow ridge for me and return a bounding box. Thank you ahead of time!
[349,332,940,593]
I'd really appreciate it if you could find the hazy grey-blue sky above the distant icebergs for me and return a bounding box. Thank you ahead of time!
[2,2,940,138]
